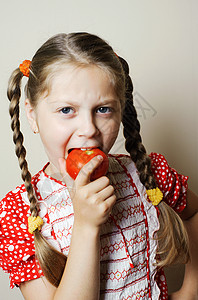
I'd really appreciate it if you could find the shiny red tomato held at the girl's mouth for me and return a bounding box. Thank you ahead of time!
[66,148,109,180]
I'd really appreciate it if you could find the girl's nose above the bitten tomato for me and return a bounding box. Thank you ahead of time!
[78,115,99,138]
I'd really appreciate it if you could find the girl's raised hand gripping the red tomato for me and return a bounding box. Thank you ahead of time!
[59,156,116,228]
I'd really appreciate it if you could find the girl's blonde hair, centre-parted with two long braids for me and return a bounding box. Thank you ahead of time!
[7,33,188,287]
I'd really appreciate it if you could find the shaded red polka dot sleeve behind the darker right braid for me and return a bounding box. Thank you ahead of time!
[149,152,188,213]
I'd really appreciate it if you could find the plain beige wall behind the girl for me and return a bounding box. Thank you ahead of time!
[0,0,198,300]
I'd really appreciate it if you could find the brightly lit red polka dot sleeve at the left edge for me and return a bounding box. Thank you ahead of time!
[0,186,43,288]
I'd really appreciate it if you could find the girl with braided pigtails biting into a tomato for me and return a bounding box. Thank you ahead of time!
[0,33,197,300]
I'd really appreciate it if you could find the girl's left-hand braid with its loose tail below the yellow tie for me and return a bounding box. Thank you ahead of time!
[7,69,66,287]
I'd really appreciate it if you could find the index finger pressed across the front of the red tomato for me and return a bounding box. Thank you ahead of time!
[75,155,103,186]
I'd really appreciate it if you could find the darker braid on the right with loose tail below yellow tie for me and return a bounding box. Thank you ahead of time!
[119,57,189,267]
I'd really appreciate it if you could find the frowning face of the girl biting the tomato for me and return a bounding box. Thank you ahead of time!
[26,66,121,175]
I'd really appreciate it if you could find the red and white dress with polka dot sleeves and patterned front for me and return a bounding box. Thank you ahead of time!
[0,153,188,300]
